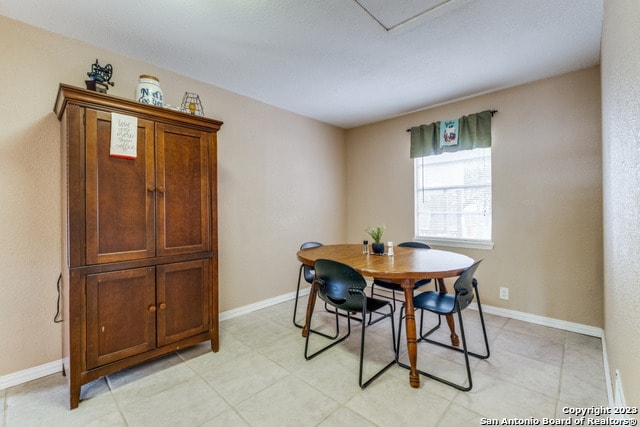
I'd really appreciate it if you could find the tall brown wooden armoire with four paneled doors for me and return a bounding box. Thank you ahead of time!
[54,84,222,409]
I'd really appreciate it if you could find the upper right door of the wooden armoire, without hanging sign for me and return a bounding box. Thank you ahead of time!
[156,123,212,256]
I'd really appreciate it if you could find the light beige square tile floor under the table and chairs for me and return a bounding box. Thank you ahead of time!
[0,297,608,427]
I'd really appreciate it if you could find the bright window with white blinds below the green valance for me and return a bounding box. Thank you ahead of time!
[414,147,492,248]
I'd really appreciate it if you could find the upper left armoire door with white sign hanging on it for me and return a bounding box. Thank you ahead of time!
[85,109,155,264]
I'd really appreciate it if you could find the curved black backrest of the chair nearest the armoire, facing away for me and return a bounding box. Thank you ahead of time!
[314,259,367,311]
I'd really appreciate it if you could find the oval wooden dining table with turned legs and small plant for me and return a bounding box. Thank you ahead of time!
[297,244,474,388]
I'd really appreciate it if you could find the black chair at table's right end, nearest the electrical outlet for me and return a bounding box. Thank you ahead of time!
[396,260,490,391]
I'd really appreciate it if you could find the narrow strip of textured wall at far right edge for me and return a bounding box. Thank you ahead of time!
[601,0,640,407]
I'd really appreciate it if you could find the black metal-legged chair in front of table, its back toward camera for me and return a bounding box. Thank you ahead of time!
[304,259,397,389]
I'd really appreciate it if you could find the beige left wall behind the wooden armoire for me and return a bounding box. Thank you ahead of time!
[0,17,346,377]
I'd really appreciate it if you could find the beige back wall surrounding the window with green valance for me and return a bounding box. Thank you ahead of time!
[347,67,603,327]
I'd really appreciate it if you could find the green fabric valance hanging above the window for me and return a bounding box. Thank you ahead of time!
[409,110,495,159]
